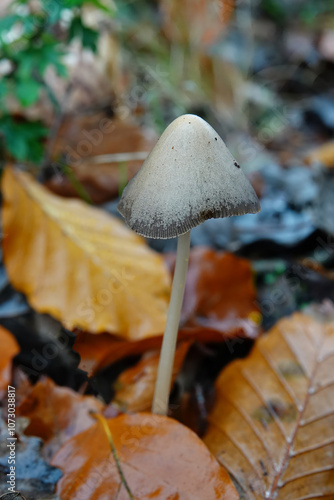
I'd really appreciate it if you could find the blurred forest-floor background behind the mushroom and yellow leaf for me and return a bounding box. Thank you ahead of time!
[0,0,334,378]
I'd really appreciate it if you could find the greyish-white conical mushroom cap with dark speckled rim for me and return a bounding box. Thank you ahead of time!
[118,115,260,239]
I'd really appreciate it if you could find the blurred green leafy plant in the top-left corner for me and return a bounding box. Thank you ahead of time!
[0,0,114,170]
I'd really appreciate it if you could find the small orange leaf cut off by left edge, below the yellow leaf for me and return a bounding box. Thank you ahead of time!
[0,326,20,401]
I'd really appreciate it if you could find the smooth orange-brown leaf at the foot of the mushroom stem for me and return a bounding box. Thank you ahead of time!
[52,413,238,500]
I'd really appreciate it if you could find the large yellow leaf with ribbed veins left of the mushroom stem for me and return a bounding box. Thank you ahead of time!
[2,168,170,340]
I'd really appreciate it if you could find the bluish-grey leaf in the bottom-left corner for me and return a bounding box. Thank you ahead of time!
[0,418,61,500]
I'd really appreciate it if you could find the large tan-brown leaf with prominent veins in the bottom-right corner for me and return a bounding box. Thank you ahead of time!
[205,313,334,500]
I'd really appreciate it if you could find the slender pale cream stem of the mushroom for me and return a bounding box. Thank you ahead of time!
[152,231,190,415]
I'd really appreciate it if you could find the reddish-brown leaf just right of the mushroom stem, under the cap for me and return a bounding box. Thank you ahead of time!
[176,247,260,338]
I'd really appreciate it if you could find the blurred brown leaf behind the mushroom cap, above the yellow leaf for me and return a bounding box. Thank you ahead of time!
[47,114,156,203]
